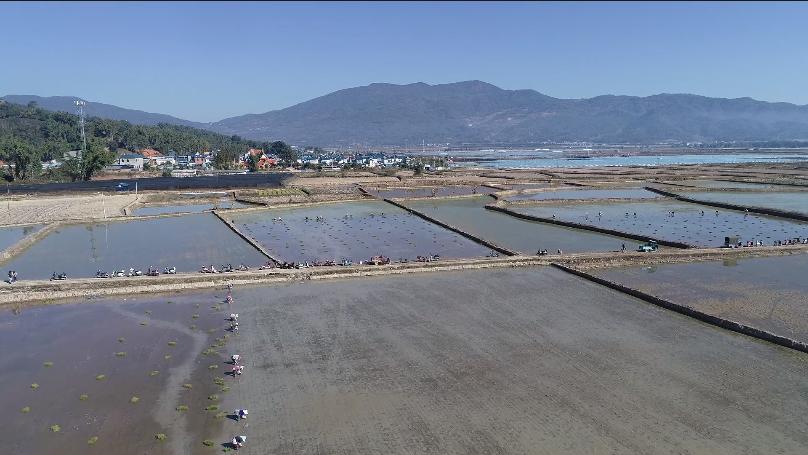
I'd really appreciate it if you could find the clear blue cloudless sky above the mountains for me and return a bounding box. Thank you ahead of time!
[0,2,808,121]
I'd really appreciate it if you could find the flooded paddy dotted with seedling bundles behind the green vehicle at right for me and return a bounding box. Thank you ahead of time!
[512,201,808,247]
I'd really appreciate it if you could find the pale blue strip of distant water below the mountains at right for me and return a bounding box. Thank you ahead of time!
[458,153,808,169]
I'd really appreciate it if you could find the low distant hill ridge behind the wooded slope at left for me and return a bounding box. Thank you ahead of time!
[0,95,206,128]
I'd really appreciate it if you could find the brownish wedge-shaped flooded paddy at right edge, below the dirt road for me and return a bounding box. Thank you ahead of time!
[597,254,808,342]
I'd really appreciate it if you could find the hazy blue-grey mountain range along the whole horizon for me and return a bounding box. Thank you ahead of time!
[2,81,808,146]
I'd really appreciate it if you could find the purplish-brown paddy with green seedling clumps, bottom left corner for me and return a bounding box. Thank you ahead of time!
[0,294,229,455]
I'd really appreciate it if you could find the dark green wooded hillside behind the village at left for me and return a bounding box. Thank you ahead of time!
[0,101,297,181]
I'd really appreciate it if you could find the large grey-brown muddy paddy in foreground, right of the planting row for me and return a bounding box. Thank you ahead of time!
[188,268,808,455]
